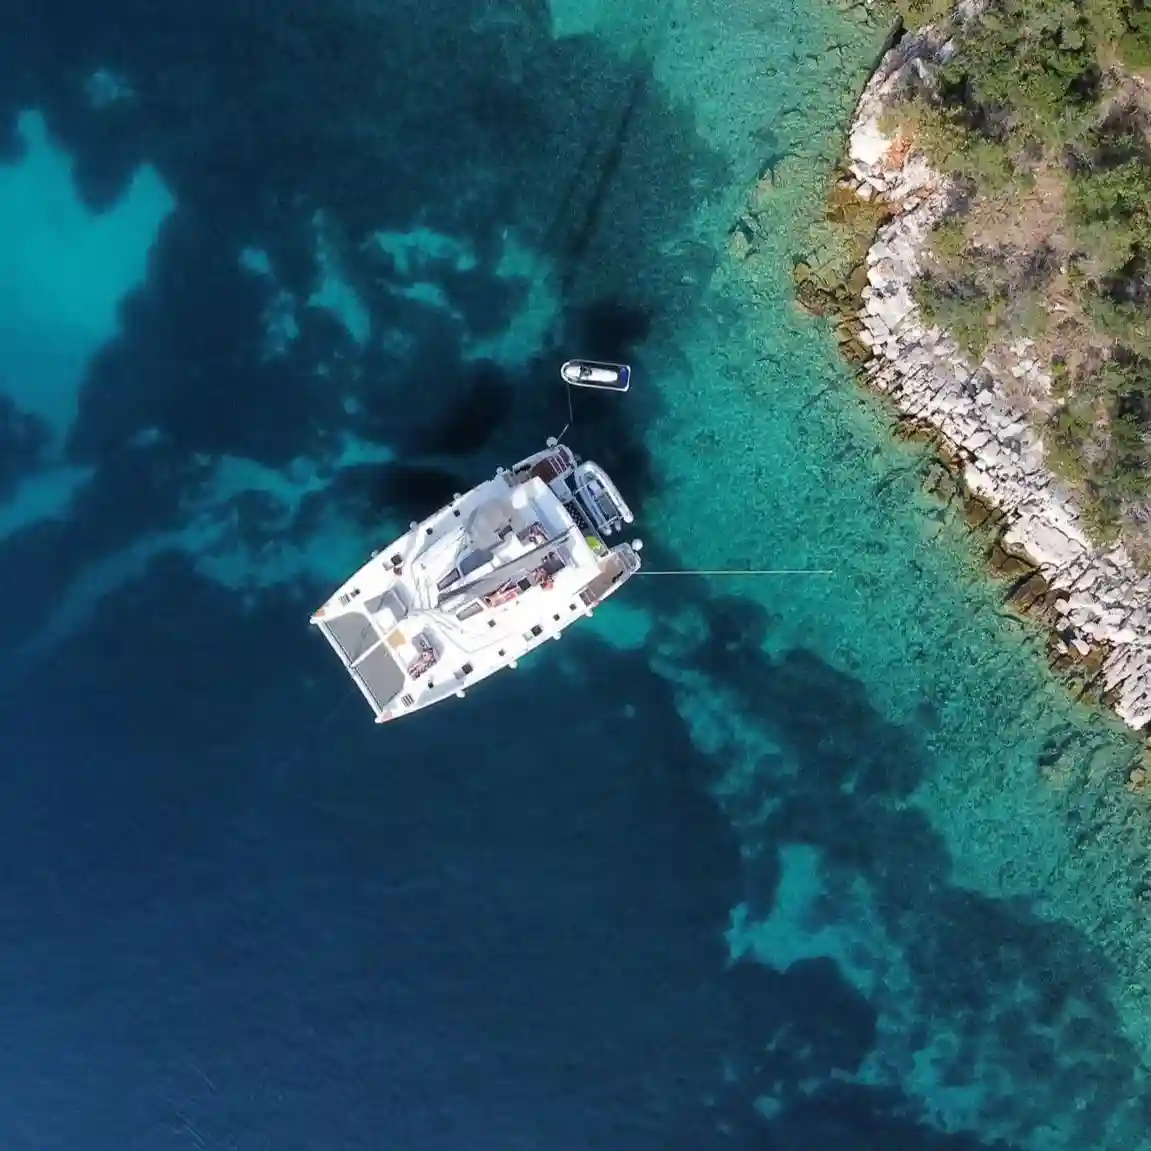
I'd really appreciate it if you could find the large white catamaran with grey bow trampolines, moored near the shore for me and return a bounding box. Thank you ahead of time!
[312,440,642,723]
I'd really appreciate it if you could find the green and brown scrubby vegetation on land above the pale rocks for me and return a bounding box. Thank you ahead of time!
[874,0,1151,551]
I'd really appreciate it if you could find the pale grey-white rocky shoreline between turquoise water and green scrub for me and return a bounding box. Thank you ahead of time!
[828,28,1151,741]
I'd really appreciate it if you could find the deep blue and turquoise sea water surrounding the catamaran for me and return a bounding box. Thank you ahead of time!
[0,0,1151,1151]
